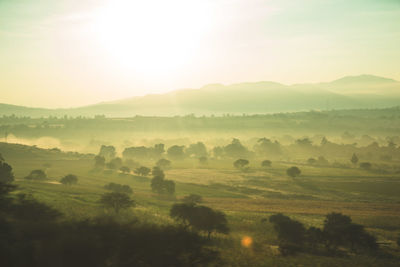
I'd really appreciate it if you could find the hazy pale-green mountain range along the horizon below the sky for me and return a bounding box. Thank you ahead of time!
[0,75,400,117]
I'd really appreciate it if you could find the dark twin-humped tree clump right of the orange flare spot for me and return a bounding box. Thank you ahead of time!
[269,212,378,255]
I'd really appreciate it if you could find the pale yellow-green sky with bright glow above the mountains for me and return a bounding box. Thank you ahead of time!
[0,0,400,108]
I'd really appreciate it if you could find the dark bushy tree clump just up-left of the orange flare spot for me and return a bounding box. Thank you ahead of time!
[170,195,229,239]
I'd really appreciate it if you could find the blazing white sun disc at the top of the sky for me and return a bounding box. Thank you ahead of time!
[92,0,212,74]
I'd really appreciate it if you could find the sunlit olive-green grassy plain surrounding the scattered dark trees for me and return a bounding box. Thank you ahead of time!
[0,143,400,266]
